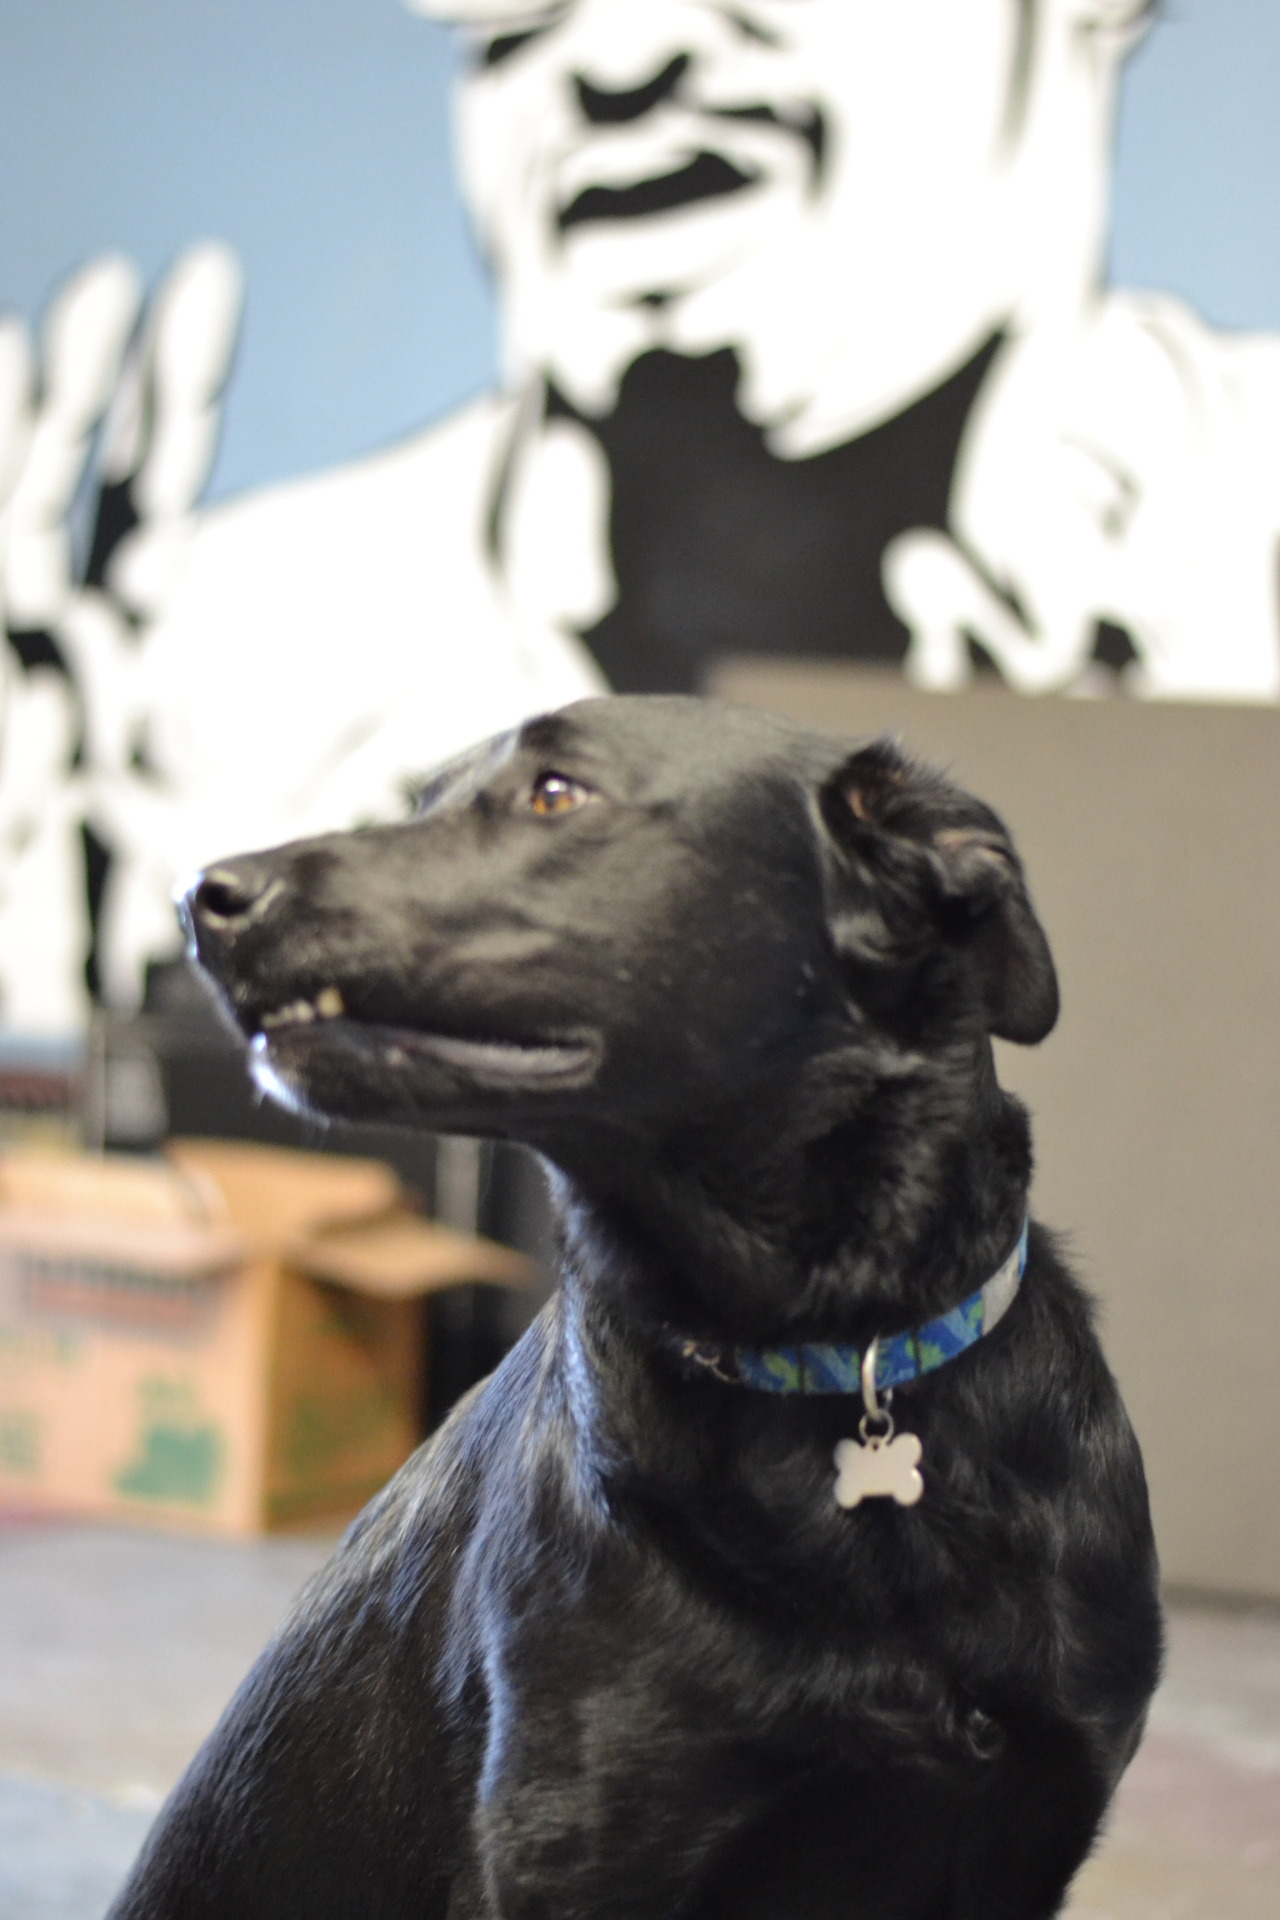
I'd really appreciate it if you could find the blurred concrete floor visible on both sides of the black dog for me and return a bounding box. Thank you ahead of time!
[0,1523,1280,1920]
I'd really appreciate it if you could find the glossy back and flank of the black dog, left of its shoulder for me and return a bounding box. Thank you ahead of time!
[107,1297,568,1920]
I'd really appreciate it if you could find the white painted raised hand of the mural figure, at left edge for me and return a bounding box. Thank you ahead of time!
[0,244,240,1033]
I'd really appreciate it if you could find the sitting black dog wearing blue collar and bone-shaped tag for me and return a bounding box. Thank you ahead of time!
[115,699,1159,1920]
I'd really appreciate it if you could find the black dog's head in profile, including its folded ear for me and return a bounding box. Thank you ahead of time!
[184,697,1057,1152]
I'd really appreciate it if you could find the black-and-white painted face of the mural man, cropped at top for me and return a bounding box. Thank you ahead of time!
[427,0,1128,451]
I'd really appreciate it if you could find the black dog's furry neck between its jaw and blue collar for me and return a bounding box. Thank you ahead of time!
[558,1043,1031,1344]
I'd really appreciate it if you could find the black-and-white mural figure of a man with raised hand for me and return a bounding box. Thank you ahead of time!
[0,0,1280,1033]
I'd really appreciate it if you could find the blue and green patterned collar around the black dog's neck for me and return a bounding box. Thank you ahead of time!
[677,1223,1029,1394]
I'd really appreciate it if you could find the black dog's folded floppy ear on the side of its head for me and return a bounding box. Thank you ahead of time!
[819,741,1057,1046]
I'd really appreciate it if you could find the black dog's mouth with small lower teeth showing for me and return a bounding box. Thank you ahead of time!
[240,983,601,1104]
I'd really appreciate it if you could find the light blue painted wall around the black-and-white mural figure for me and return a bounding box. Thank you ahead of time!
[0,0,1280,492]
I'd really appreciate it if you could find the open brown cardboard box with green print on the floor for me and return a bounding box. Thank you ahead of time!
[0,1140,533,1534]
